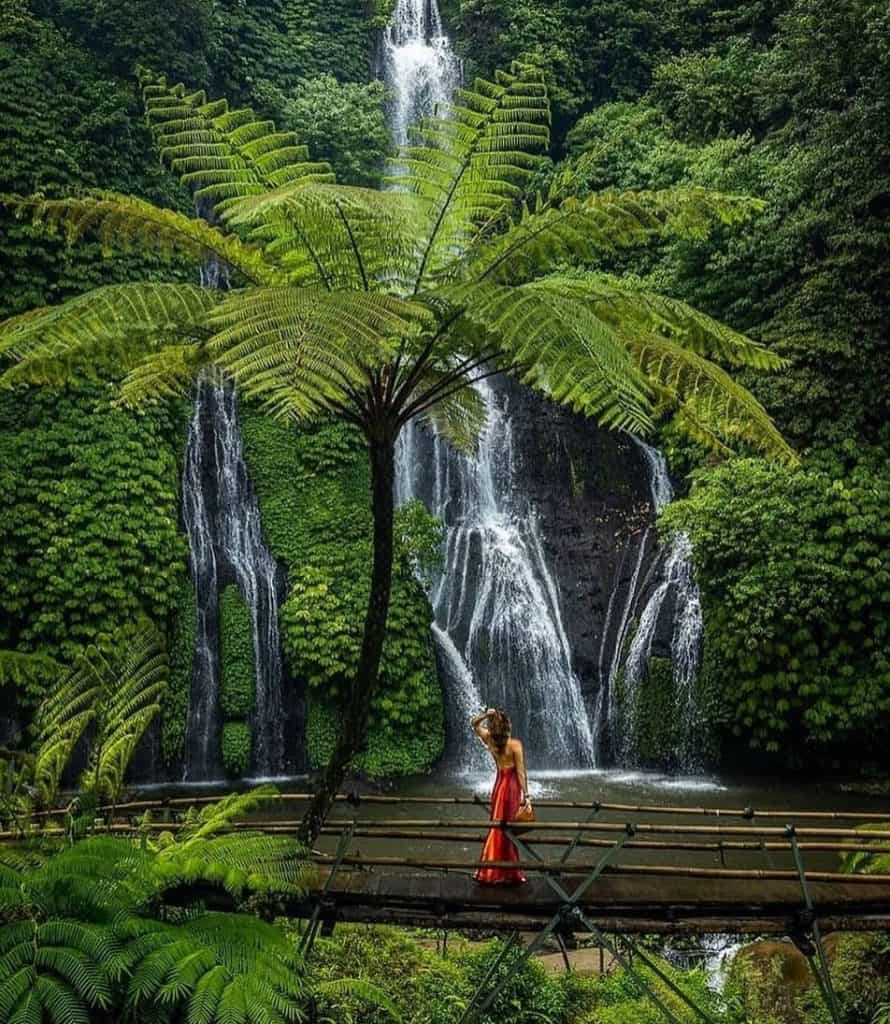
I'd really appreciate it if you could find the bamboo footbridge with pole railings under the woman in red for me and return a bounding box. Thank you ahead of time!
[10,794,890,1020]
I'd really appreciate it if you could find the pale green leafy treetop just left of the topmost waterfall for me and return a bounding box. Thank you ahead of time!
[257,75,390,187]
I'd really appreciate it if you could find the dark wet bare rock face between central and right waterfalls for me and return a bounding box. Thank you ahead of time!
[502,382,670,760]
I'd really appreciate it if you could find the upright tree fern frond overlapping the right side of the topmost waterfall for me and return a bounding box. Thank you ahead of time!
[388,65,550,291]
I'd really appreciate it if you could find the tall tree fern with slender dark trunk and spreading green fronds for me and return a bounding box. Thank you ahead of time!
[0,67,794,839]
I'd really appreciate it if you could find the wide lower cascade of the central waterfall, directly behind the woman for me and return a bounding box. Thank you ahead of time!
[396,383,595,768]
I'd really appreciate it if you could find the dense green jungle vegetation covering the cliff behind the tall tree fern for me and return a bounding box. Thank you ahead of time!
[0,0,890,773]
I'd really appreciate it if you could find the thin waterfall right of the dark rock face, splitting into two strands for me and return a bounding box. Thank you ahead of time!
[609,441,703,766]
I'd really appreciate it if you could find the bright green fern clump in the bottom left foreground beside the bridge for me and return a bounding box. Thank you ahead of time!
[0,787,317,1024]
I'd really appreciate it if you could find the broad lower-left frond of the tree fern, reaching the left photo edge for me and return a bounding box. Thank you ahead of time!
[0,282,223,387]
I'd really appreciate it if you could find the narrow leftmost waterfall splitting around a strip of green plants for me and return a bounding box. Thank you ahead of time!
[182,381,285,780]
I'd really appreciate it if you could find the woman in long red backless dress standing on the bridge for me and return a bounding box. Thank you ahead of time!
[472,708,528,885]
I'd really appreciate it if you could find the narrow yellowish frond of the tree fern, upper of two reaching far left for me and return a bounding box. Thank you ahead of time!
[0,191,283,285]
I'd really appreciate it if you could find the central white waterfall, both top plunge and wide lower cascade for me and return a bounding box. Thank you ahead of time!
[383,0,595,770]
